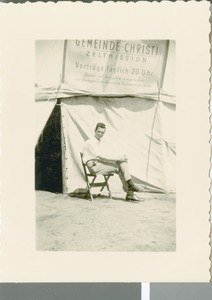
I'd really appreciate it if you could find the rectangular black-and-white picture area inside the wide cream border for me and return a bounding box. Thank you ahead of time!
[35,39,176,252]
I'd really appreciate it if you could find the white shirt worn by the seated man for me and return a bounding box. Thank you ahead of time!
[82,136,102,163]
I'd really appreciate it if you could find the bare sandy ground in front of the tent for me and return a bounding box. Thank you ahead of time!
[36,191,176,251]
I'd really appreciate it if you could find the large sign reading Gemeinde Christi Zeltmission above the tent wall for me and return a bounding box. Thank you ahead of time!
[64,40,168,95]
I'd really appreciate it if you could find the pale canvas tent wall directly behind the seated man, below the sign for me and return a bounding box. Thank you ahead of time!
[61,96,175,193]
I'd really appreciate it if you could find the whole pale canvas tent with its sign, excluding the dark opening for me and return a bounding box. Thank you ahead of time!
[35,40,176,193]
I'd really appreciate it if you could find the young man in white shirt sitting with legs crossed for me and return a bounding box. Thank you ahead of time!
[83,123,141,200]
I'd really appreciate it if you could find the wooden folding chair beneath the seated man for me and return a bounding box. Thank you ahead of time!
[80,152,113,201]
